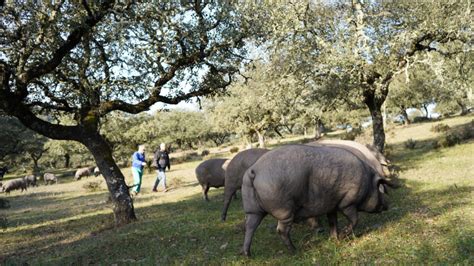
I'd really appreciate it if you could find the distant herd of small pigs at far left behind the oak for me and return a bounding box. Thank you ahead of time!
[0,166,100,194]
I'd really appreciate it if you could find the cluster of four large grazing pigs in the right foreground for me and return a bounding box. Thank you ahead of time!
[196,140,397,256]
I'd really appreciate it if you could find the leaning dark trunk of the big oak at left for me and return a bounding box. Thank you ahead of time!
[84,133,137,226]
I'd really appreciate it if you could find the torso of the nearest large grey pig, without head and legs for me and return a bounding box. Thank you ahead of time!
[249,145,374,218]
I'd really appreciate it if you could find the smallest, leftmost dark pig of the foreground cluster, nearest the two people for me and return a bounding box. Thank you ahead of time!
[196,159,227,201]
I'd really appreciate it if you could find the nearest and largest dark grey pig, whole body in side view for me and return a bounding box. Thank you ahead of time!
[242,145,390,256]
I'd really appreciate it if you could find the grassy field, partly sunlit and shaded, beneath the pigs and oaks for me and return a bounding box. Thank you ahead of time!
[0,116,474,265]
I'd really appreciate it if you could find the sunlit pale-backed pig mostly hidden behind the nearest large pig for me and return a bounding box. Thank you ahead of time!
[306,139,390,177]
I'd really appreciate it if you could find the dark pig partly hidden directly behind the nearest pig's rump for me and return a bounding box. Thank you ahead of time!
[221,148,269,221]
